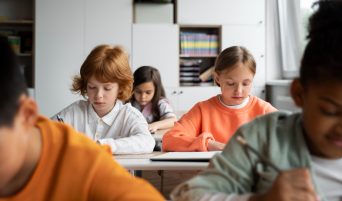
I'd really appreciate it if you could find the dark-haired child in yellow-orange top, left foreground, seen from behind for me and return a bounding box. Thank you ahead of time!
[0,36,164,201]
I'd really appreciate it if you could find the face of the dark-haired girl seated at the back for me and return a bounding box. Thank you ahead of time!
[134,82,155,106]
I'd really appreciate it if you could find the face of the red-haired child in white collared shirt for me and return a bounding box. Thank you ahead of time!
[87,77,119,117]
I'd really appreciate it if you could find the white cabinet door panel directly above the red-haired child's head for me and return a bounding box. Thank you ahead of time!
[84,0,133,55]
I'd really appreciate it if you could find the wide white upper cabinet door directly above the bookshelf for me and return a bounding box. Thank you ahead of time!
[177,0,265,24]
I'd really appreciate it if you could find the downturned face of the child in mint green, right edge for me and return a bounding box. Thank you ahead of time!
[302,82,342,159]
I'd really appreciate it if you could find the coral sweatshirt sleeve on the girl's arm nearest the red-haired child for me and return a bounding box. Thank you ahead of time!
[162,104,214,151]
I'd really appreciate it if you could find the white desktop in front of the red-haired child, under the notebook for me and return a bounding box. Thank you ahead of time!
[114,152,209,170]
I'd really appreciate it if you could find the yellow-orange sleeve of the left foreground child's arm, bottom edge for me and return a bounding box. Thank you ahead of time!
[89,154,165,201]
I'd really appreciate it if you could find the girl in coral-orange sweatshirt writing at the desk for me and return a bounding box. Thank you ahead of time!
[163,46,276,151]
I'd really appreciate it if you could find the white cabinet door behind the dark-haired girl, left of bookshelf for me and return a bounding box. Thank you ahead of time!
[132,24,179,87]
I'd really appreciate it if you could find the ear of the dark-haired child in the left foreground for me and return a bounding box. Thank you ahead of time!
[18,95,38,128]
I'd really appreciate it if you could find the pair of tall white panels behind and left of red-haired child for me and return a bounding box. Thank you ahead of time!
[35,0,133,116]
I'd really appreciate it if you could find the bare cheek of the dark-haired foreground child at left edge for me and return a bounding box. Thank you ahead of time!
[0,120,27,191]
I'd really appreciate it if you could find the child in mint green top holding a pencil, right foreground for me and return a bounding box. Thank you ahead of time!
[171,0,342,201]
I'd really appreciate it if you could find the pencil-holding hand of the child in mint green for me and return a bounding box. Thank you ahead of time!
[249,168,319,201]
